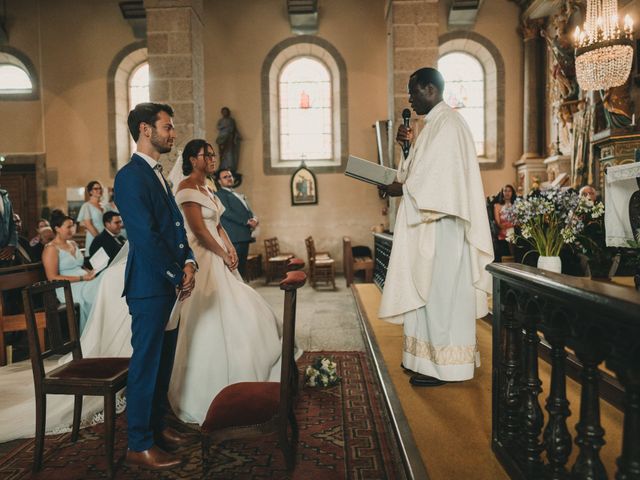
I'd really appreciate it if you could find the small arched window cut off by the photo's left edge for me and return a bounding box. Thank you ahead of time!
[0,47,38,100]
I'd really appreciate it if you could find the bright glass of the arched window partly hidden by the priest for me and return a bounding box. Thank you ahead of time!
[438,52,486,157]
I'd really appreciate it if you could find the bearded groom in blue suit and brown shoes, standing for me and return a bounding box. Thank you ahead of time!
[114,103,196,470]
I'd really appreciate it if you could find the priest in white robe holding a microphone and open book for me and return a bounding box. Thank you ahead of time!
[379,68,493,386]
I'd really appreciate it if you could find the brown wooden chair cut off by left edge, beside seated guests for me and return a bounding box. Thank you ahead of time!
[0,263,45,366]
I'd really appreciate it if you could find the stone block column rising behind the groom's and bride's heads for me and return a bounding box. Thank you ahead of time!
[144,0,205,167]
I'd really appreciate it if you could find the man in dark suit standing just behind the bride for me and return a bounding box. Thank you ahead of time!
[216,169,258,278]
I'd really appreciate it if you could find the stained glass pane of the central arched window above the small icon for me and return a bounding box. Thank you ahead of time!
[278,57,333,162]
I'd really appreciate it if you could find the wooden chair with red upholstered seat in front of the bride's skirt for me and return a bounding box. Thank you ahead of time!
[200,270,306,476]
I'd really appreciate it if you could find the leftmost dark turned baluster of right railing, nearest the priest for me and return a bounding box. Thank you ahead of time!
[500,304,522,445]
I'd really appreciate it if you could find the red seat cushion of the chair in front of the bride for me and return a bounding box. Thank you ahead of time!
[202,382,280,433]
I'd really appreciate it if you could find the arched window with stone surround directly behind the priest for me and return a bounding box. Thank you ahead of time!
[438,31,505,170]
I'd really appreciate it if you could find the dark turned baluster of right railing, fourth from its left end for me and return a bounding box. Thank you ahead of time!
[571,342,607,480]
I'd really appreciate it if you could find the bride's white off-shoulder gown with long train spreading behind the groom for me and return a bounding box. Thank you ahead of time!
[0,190,288,443]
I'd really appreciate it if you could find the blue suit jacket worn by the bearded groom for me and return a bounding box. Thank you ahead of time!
[114,154,193,298]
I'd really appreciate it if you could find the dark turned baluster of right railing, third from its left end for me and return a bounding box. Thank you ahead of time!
[543,318,571,479]
